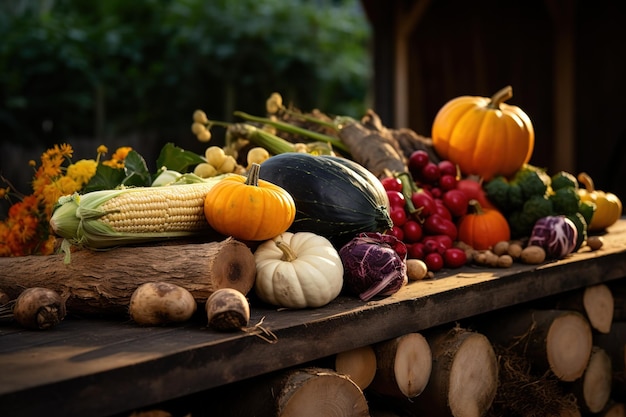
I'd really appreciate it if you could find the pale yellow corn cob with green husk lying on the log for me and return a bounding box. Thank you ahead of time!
[50,177,223,249]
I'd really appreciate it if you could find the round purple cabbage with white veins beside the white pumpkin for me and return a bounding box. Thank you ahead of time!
[339,233,408,301]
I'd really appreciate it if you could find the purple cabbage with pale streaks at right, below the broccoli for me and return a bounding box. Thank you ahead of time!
[528,216,578,259]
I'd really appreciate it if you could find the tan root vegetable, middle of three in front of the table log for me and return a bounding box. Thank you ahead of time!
[129,282,197,326]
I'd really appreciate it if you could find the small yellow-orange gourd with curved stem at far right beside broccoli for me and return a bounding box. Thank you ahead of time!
[578,172,622,232]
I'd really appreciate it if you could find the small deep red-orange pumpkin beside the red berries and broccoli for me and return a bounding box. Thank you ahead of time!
[457,200,511,250]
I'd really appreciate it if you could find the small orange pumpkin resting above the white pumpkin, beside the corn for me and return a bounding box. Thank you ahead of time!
[204,163,296,241]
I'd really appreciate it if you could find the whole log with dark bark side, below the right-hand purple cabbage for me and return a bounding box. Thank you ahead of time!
[477,309,593,381]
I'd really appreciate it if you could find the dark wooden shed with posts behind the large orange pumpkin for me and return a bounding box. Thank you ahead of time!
[362,0,626,200]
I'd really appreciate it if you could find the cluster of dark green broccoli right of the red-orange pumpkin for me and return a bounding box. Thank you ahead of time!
[484,164,595,249]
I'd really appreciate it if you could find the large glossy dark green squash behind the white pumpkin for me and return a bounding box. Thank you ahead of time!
[260,153,393,247]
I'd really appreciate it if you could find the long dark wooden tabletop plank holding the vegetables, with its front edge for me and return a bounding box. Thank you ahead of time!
[0,220,626,417]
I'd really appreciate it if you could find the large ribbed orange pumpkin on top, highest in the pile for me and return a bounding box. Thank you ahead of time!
[432,86,535,181]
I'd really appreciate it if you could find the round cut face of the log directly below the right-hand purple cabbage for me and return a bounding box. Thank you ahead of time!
[546,312,593,381]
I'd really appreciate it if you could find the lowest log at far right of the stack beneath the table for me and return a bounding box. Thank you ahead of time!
[571,346,613,413]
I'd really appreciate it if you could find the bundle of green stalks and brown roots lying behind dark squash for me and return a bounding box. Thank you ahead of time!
[192,93,437,178]
